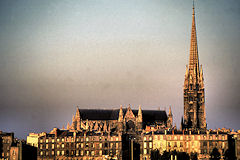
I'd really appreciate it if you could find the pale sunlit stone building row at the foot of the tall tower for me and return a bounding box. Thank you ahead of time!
[143,130,228,160]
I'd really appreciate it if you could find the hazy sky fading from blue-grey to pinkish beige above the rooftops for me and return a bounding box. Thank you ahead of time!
[0,0,240,138]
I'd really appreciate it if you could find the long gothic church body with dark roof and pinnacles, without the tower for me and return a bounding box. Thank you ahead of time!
[70,106,169,133]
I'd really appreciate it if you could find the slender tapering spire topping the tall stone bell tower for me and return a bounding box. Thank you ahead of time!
[189,1,199,78]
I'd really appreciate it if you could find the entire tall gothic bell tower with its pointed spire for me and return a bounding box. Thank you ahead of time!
[183,3,207,131]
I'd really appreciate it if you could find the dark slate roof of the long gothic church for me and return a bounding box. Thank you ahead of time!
[80,108,167,122]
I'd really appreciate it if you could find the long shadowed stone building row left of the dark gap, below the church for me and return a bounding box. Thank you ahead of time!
[38,129,122,160]
